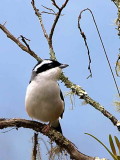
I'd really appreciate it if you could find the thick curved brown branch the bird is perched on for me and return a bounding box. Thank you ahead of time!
[0,118,95,160]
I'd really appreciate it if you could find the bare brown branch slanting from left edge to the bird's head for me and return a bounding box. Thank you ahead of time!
[0,24,42,61]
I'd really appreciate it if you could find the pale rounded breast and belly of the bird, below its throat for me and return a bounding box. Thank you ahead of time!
[25,79,64,122]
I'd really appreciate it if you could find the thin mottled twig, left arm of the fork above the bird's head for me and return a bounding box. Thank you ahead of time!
[31,0,49,41]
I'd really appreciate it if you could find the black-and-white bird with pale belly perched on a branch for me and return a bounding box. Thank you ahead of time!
[25,59,68,134]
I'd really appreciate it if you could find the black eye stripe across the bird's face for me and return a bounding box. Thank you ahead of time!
[34,60,61,74]
